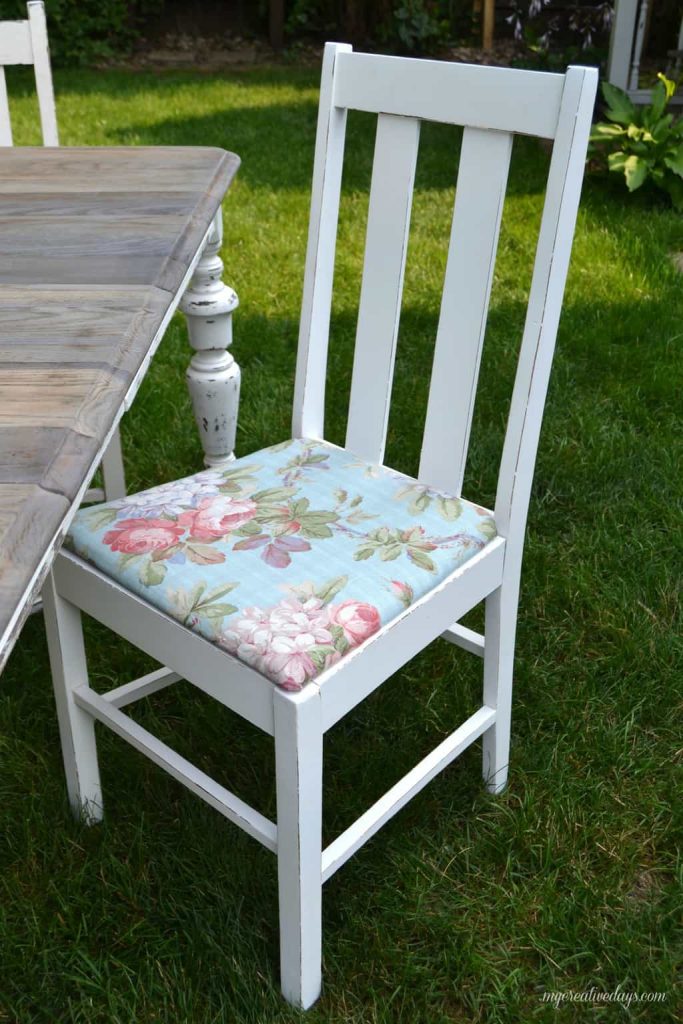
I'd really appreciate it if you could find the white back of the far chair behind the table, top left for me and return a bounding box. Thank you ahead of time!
[0,0,59,145]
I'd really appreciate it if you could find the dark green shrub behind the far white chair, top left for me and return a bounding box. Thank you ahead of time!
[0,0,164,67]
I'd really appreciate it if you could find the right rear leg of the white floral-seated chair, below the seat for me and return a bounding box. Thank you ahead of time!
[482,584,517,793]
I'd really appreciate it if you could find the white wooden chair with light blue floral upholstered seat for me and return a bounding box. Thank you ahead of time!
[44,43,597,1008]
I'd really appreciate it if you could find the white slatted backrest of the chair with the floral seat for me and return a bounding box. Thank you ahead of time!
[293,43,598,552]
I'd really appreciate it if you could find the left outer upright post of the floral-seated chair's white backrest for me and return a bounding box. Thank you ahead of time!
[292,43,351,438]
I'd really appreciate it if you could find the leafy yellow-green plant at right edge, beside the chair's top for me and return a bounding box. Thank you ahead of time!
[591,75,683,210]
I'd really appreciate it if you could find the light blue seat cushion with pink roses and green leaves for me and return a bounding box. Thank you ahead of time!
[67,439,496,690]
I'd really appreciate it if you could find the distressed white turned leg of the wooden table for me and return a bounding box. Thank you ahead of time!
[180,210,240,466]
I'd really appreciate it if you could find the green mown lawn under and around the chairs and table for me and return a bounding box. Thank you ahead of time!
[0,70,683,1024]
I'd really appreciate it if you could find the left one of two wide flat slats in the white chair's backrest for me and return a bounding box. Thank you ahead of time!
[346,114,420,463]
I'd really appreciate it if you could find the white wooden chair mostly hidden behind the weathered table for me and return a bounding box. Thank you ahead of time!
[0,0,126,501]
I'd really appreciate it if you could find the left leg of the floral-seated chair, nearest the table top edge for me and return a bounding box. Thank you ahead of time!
[43,573,102,824]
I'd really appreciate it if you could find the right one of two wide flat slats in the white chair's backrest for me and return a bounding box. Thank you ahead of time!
[419,128,512,495]
